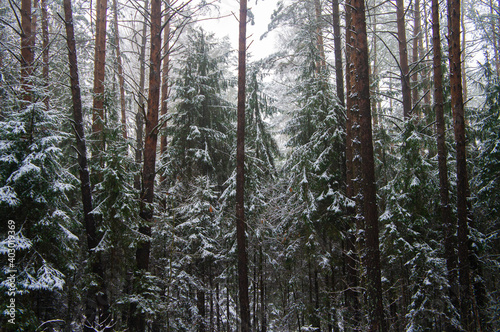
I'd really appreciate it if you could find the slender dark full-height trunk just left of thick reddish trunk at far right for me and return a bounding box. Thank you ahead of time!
[432,0,458,324]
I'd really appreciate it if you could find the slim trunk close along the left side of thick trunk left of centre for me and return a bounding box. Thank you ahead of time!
[134,0,149,190]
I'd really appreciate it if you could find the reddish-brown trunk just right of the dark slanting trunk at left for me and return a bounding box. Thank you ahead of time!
[92,0,108,150]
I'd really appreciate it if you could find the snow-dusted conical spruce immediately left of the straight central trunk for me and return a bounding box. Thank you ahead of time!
[165,29,234,185]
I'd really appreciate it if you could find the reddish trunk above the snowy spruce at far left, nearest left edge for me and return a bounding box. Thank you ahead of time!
[21,0,35,103]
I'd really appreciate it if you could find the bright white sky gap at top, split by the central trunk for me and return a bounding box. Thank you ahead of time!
[198,0,278,61]
